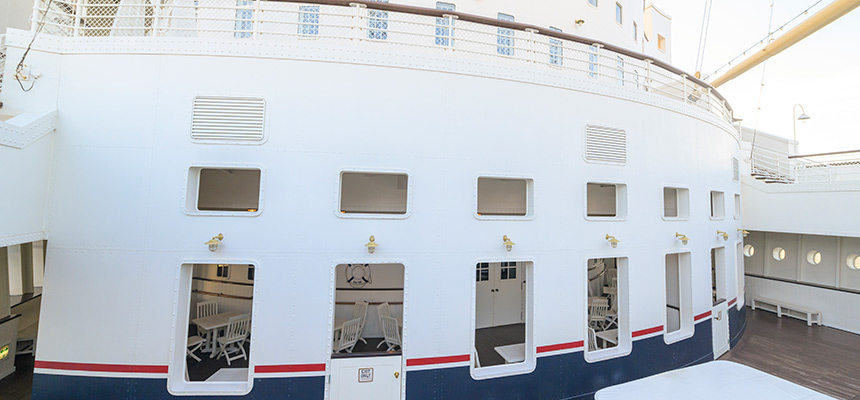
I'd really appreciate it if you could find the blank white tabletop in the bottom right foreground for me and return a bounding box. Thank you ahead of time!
[594,361,833,400]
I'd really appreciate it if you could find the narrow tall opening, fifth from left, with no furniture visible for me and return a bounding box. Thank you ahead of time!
[664,253,693,343]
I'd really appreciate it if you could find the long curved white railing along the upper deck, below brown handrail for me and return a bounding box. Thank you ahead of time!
[33,0,732,123]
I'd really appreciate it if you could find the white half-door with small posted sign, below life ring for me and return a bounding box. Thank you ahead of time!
[329,356,403,400]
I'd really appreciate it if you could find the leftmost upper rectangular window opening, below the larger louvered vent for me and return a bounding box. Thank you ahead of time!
[186,167,262,215]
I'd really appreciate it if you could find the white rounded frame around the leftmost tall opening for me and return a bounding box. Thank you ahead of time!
[167,258,260,396]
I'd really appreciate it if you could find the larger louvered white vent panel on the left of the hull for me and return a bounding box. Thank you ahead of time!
[191,96,266,142]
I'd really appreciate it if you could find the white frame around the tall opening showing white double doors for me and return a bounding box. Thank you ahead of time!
[474,257,536,380]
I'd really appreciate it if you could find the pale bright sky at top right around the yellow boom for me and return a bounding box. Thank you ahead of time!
[652,0,860,154]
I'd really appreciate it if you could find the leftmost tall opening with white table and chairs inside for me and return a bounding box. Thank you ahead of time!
[174,264,254,394]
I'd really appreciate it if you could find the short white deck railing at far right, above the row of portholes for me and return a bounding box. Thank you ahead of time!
[751,149,860,183]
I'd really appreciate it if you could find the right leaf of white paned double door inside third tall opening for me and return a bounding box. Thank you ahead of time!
[493,262,524,326]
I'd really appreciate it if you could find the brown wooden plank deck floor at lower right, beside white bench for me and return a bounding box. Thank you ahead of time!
[720,309,860,400]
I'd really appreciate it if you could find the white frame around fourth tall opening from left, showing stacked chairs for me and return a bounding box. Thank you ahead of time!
[582,253,633,364]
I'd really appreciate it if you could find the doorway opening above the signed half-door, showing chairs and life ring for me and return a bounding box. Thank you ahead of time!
[332,263,404,358]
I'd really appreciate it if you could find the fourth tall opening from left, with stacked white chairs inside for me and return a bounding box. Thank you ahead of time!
[585,258,631,362]
